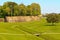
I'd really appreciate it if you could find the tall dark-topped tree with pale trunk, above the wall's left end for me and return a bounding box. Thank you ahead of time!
[3,2,17,16]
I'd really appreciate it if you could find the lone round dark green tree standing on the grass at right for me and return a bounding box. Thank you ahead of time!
[46,13,59,25]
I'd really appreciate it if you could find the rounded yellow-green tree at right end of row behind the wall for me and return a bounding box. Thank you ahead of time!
[31,3,41,16]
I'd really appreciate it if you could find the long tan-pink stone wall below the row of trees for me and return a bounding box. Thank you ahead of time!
[6,16,41,22]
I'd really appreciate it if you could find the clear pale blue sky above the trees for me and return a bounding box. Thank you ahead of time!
[0,0,60,14]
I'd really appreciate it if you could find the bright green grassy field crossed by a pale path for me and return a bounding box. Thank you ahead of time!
[0,18,60,40]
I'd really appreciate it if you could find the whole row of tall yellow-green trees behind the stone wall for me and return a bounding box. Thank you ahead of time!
[0,2,41,18]
